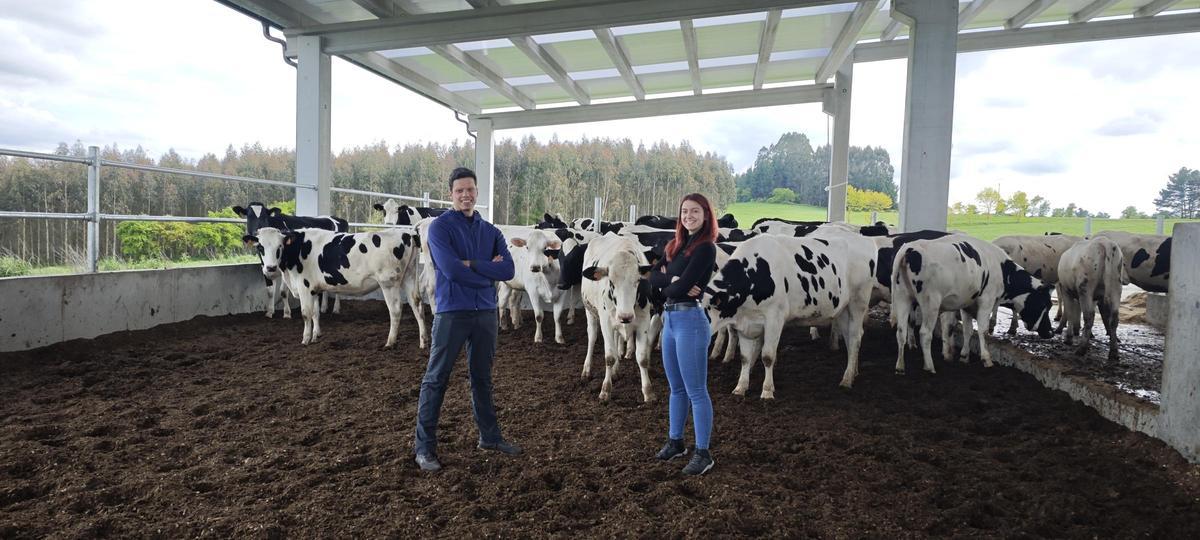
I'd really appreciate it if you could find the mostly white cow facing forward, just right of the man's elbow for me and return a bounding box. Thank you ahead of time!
[498,229,570,343]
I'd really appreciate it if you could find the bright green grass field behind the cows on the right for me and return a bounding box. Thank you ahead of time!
[725,203,1195,241]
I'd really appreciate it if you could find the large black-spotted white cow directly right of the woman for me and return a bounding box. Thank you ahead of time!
[703,235,875,391]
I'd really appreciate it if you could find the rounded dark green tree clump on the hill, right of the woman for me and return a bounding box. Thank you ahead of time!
[736,132,898,208]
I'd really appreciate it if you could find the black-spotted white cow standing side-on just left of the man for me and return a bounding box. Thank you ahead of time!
[242,227,427,349]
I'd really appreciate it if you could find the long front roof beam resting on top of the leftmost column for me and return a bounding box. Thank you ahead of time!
[284,0,839,54]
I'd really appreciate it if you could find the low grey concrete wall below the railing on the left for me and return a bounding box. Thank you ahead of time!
[0,263,266,352]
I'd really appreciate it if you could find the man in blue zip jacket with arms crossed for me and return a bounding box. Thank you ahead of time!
[415,167,521,472]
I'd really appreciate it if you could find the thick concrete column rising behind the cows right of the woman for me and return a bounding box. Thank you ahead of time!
[892,0,959,232]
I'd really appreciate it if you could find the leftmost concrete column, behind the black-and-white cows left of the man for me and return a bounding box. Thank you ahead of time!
[293,36,334,216]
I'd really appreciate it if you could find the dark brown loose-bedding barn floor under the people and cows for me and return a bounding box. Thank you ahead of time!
[0,302,1200,538]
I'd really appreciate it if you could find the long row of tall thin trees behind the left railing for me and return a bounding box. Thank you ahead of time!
[0,137,734,265]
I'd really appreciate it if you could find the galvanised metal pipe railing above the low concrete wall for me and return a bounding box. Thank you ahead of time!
[0,146,441,272]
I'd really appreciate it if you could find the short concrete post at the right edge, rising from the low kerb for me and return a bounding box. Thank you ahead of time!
[1158,223,1200,463]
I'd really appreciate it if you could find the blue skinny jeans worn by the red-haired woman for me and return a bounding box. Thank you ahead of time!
[662,308,713,449]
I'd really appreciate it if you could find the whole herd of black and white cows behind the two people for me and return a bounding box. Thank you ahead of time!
[234,200,1171,401]
